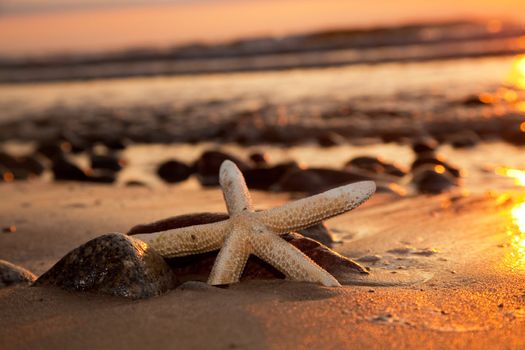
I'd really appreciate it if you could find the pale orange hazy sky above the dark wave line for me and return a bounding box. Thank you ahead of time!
[0,0,525,56]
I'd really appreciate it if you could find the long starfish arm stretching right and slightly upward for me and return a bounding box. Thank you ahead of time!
[255,181,376,233]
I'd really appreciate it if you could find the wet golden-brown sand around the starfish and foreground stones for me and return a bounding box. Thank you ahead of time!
[0,182,525,349]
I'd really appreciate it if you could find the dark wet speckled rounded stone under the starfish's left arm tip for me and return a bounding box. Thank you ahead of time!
[34,233,175,299]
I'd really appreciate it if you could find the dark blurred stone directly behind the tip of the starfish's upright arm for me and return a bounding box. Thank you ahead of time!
[194,151,250,186]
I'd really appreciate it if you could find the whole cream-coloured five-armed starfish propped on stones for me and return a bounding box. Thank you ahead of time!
[134,160,376,287]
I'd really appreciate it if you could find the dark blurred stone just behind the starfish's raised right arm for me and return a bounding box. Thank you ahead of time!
[276,168,372,194]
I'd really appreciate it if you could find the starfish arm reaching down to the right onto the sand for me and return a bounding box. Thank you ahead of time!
[249,227,341,287]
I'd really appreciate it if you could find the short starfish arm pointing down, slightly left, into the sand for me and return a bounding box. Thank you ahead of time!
[208,229,251,285]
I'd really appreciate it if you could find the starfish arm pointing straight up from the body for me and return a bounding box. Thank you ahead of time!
[219,160,253,216]
